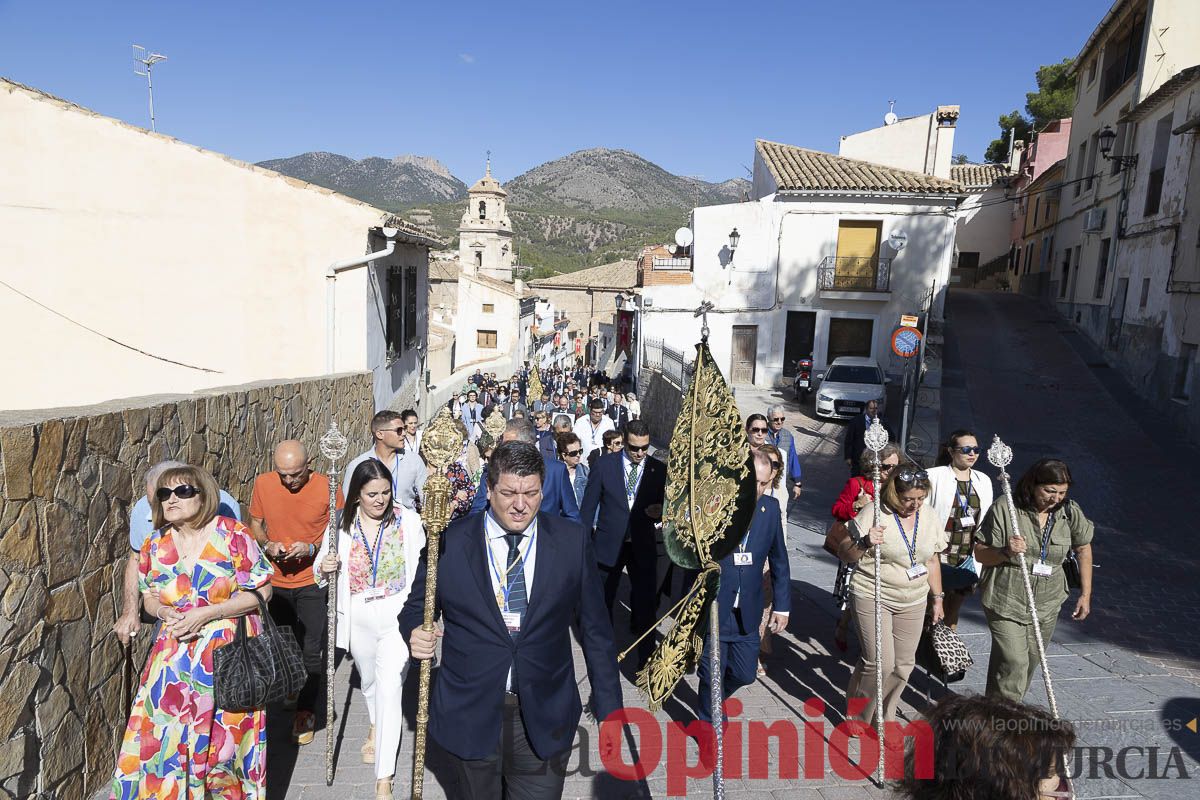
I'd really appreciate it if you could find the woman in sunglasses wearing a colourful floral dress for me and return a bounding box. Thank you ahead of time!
[112,467,271,800]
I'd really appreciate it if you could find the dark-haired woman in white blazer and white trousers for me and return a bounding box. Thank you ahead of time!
[313,458,425,799]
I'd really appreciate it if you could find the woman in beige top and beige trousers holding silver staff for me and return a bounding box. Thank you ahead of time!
[839,465,946,722]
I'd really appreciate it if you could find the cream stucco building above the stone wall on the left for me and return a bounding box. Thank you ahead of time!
[0,82,426,409]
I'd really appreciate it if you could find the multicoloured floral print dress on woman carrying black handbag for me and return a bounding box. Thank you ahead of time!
[112,517,271,800]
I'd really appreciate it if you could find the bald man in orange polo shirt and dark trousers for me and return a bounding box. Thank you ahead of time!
[250,439,344,745]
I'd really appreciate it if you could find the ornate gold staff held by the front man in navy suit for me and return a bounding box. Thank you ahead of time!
[413,407,460,800]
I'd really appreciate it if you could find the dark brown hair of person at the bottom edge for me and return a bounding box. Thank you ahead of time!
[896,694,1075,800]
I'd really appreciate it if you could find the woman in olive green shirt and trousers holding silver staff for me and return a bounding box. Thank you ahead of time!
[974,458,1094,702]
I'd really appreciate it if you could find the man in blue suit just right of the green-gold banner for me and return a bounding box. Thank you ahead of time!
[696,451,792,722]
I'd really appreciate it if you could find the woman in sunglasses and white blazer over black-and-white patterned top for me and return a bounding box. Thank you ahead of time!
[928,429,994,628]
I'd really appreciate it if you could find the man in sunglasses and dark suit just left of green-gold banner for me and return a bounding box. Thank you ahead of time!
[580,420,667,666]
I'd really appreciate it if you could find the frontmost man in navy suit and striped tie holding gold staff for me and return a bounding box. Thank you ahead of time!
[398,441,622,800]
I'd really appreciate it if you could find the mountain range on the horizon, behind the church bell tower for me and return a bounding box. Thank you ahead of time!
[258,148,750,277]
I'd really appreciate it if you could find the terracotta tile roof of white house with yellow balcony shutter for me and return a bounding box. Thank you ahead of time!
[756,139,962,194]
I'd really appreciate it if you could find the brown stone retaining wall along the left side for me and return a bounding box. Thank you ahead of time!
[0,373,374,800]
